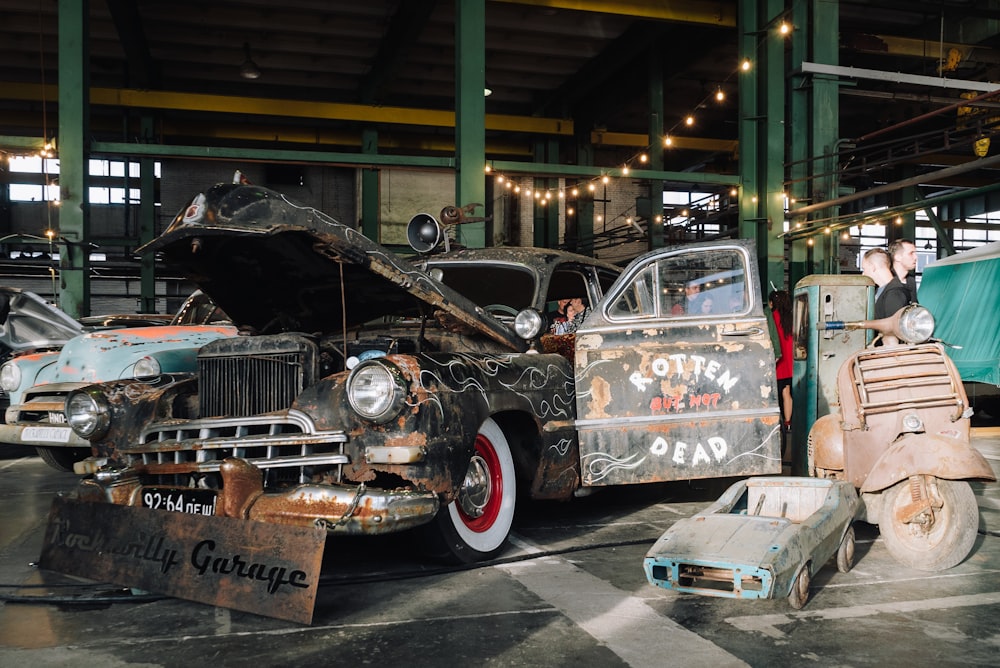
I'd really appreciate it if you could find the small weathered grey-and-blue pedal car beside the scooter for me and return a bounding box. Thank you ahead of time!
[643,476,858,609]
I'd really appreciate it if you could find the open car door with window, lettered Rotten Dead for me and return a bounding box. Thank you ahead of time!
[575,241,781,486]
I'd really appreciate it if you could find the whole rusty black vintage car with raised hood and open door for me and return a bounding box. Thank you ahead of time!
[66,185,781,561]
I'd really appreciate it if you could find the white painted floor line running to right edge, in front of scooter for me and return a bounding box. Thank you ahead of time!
[725,592,1000,639]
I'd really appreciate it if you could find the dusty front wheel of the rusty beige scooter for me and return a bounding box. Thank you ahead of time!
[879,476,979,571]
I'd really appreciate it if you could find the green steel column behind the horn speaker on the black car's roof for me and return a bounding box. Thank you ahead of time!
[455,0,486,248]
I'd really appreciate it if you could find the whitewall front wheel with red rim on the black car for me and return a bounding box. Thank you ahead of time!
[426,419,517,564]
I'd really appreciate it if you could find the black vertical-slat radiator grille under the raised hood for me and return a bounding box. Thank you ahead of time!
[198,334,318,418]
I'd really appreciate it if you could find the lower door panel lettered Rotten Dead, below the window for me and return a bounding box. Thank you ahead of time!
[577,326,781,485]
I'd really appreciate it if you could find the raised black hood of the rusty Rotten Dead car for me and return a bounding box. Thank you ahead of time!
[144,184,526,351]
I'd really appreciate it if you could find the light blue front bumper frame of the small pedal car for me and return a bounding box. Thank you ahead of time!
[642,557,774,599]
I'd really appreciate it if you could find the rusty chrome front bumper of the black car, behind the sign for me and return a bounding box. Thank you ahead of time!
[78,457,440,535]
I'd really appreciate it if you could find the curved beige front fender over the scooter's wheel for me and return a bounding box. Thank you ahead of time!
[861,434,996,492]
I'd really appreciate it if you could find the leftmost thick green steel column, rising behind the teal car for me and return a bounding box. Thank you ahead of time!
[57,0,90,318]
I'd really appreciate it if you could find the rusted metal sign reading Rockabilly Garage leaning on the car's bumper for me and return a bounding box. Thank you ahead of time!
[41,496,326,624]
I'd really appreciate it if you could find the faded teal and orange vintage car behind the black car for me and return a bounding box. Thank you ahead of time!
[0,290,238,471]
